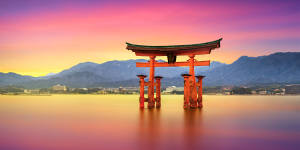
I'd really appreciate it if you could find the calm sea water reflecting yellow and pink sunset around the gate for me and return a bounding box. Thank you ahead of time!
[0,95,300,150]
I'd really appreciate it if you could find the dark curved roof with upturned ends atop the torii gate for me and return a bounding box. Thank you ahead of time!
[126,38,222,53]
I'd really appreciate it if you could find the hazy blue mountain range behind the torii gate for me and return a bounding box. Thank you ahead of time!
[0,52,300,88]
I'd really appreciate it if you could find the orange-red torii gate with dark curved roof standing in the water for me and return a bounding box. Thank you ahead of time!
[126,38,222,108]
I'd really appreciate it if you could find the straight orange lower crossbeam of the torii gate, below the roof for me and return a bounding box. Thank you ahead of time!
[136,60,210,67]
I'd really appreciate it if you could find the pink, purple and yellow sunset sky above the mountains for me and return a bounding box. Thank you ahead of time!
[0,0,300,76]
